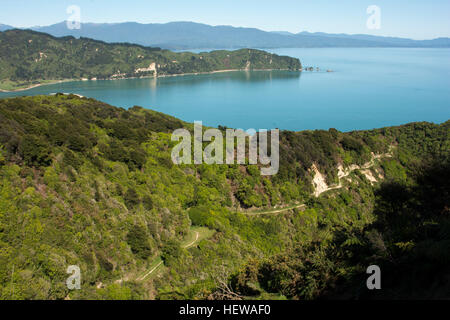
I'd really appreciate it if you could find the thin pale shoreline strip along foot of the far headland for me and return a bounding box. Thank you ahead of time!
[0,69,303,93]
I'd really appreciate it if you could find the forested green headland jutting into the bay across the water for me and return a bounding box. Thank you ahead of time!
[0,29,302,90]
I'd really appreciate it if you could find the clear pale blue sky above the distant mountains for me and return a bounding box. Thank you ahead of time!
[0,0,450,39]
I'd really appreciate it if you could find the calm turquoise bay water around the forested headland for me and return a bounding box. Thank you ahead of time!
[0,48,450,131]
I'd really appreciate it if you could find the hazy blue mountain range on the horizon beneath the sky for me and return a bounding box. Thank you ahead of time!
[0,22,450,49]
